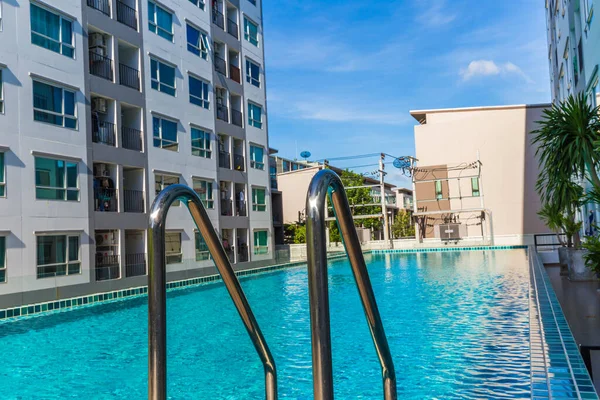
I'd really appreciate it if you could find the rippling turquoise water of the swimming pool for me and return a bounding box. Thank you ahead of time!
[0,250,531,400]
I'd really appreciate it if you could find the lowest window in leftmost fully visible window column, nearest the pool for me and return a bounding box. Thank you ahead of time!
[37,235,81,279]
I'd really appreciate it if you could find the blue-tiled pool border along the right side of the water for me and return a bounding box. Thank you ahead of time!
[528,247,598,399]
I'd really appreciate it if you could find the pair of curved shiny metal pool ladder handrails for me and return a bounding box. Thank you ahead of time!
[148,169,397,400]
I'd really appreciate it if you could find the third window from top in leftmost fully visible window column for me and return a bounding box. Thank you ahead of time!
[35,157,79,201]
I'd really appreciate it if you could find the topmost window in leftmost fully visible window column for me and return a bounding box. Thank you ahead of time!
[30,3,75,58]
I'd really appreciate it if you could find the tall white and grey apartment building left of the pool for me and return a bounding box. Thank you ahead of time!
[0,0,273,308]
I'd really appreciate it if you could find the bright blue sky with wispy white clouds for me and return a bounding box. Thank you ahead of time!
[263,0,550,183]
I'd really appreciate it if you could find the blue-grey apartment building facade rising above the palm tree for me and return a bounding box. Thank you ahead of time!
[546,0,600,105]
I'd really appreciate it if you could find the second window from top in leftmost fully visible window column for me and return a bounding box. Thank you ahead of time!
[33,81,77,129]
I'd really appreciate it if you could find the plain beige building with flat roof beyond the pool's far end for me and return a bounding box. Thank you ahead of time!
[410,104,549,245]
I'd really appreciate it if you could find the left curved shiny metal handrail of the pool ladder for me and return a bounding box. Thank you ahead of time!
[148,185,277,400]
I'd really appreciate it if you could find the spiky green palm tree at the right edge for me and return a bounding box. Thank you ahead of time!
[532,94,600,203]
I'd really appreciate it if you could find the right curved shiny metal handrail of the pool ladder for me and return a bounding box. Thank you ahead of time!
[306,169,397,400]
